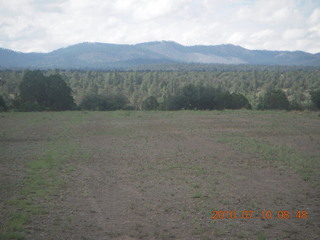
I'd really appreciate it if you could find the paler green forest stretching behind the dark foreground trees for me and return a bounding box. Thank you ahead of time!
[0,65,320,109]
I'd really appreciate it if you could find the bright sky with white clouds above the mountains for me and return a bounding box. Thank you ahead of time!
[0,0,320,53]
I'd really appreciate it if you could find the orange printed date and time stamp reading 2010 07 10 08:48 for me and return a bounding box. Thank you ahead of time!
[212,210,309,219]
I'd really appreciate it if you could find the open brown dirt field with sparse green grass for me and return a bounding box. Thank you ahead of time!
[0,111,320,240]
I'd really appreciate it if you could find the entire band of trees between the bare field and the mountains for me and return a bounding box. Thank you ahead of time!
[0,70,320,111]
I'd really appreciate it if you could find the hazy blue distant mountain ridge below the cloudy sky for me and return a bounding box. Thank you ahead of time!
[0,41,320,70]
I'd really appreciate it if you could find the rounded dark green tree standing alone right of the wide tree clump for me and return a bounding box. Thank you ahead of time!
[258,89,290,110]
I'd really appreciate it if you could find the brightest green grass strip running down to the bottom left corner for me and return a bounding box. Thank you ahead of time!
[1,143,86,239]
